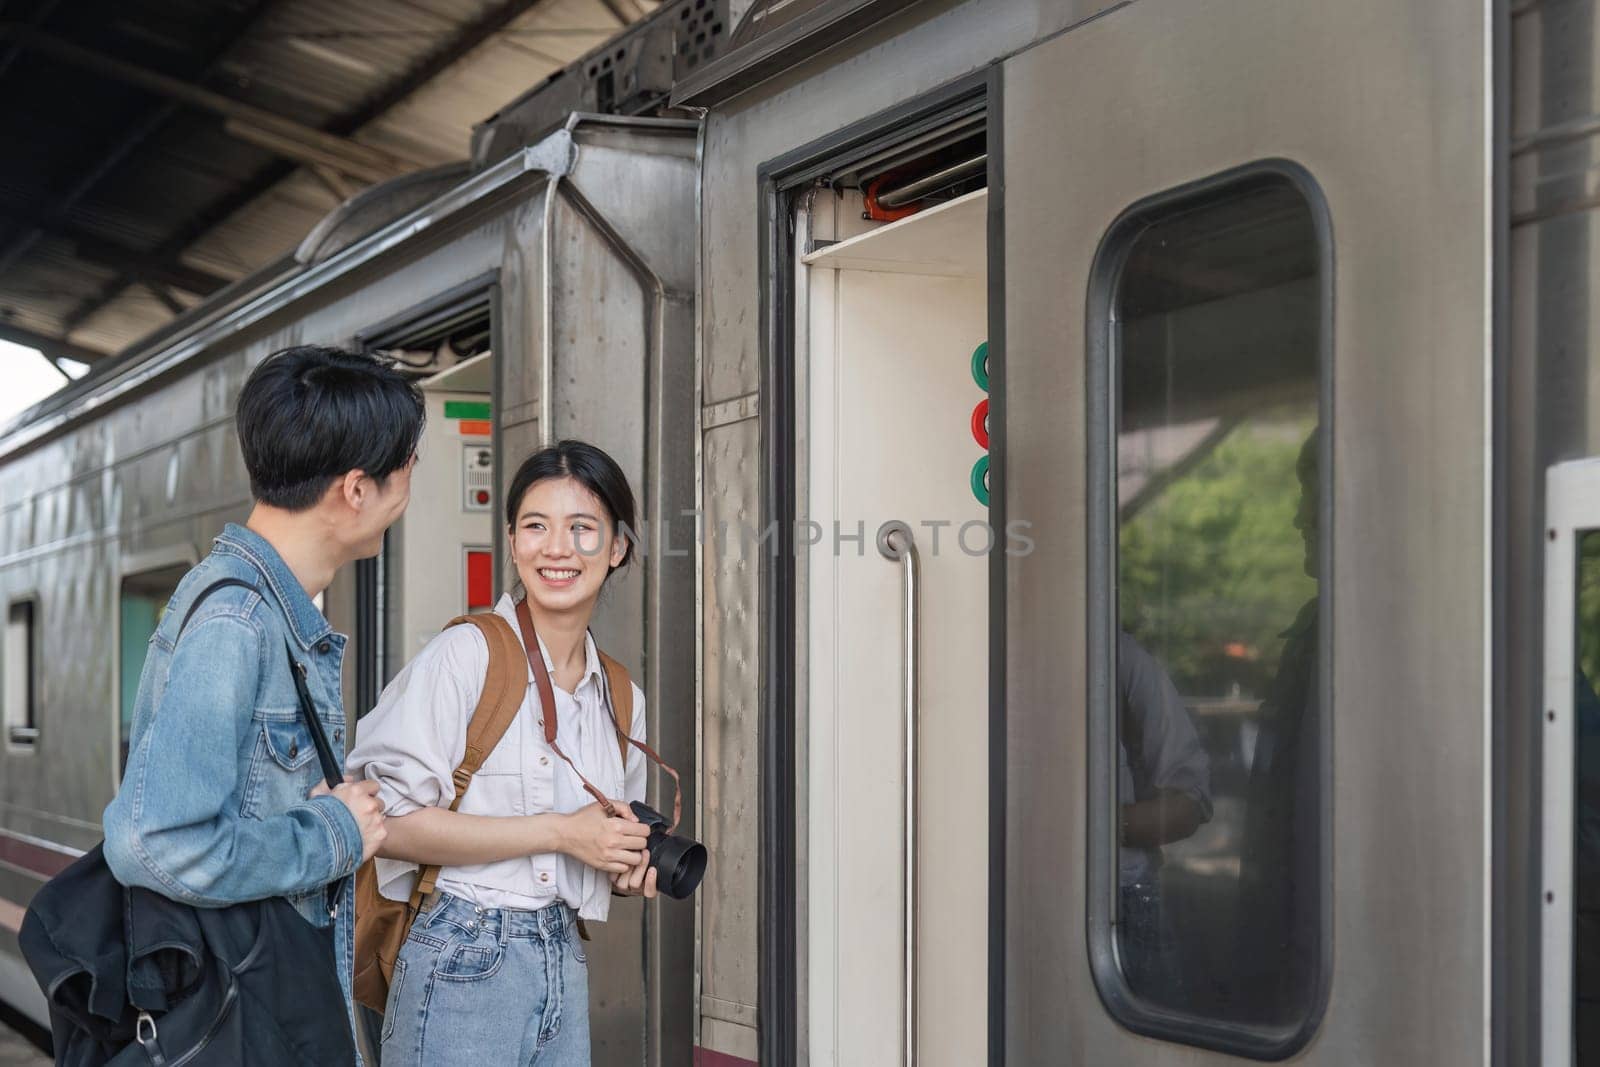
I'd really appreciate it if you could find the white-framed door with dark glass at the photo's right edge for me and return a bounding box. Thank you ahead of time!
[1539,459,1600,1067]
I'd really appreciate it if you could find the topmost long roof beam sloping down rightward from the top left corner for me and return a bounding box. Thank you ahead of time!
[0,22,426,182]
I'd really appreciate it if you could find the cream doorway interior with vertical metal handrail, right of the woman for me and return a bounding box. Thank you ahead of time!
[797,120,995,1067]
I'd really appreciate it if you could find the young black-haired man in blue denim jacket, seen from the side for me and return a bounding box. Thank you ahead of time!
[104,346,424,1049]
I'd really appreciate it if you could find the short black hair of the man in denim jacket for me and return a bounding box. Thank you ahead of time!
[234,344,426,512]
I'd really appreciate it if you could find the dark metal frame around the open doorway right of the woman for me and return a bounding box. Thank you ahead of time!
[757,68,1005,1067]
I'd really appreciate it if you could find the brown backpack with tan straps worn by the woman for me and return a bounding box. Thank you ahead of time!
[352,613,634,1011]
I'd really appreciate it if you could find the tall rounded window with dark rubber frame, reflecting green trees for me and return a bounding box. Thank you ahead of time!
[1093,166,1330,1056]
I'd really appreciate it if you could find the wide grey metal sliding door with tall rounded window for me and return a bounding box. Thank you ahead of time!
[990,0,1493,1064]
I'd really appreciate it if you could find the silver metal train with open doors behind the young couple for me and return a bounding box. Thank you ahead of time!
[0,0,1600,1067]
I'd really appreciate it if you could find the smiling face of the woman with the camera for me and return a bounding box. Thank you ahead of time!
[510,477,627,614]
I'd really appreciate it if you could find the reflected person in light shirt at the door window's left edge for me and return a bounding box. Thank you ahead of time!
[1117,632,1211,1005]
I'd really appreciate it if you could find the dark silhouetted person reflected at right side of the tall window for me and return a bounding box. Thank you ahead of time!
[1235,429,1322,1022]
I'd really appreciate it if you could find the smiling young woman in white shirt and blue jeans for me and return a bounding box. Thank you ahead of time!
[350,442,656,1067]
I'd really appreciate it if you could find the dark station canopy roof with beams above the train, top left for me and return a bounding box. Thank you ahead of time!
[0,0,658,378]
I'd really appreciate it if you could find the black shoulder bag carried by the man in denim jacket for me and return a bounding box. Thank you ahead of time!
[18,577,355,1067]
